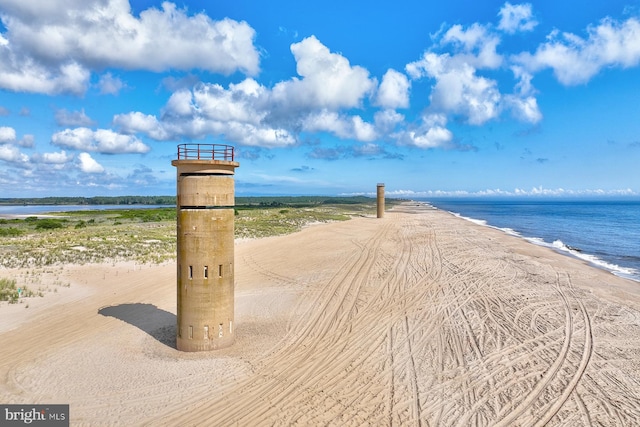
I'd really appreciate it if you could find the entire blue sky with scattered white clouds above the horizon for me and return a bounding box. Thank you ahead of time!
[0,0,640,197]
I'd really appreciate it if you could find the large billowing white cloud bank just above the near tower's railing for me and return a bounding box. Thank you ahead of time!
[113,36,384,147]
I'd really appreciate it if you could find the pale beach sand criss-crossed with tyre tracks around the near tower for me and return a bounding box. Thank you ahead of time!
[0,206,640,426]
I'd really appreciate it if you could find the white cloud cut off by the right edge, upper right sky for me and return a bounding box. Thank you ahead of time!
[513,18,640,86]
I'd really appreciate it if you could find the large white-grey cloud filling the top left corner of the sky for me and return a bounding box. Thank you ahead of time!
[0,0,260,94]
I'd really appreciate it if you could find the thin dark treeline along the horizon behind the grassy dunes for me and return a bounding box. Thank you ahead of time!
[0,196,388,208]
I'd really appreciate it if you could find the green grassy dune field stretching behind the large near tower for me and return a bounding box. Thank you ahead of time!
[0,197,394,268]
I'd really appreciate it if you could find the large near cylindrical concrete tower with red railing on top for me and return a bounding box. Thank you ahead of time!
[171,144,240,351]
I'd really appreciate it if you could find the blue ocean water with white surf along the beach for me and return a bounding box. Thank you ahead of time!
[423,198,640,281]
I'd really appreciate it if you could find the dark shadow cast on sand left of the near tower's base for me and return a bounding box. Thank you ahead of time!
[98,303,176,348]
